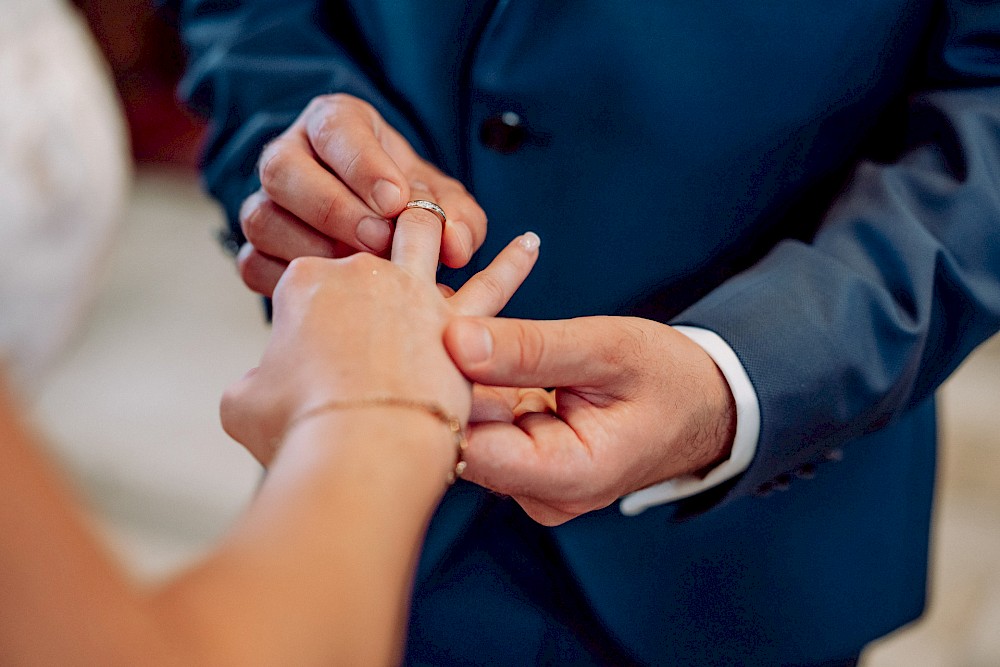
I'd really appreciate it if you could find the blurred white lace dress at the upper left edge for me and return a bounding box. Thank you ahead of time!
[0,0,131,395]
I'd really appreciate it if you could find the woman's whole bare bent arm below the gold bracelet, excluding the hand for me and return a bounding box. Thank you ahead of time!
[0,374,454,665]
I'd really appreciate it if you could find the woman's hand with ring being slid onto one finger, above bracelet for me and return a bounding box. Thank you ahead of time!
[221,201,538,465]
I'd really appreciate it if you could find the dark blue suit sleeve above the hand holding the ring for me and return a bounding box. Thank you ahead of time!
[171,0,422,249]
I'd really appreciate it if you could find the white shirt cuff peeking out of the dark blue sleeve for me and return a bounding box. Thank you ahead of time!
[619,326,760,516]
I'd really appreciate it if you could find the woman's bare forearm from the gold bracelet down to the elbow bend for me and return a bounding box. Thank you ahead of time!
[150,408,455,664]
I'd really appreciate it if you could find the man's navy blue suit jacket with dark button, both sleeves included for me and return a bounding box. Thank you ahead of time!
[176,0,1000,664]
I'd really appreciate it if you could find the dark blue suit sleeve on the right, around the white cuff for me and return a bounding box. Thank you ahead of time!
[675,1,1000,506]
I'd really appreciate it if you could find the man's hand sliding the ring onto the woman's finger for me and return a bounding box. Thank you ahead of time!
[238,94,486,296]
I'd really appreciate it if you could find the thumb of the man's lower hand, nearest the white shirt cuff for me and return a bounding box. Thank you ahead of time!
[444,317,620,387]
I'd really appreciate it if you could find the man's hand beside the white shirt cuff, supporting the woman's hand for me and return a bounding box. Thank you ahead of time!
[445,317,736,525]
